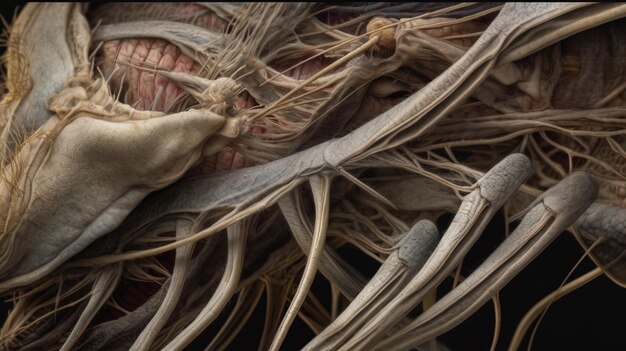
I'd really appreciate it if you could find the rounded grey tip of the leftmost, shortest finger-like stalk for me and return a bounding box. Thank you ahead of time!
[398,219,440,269]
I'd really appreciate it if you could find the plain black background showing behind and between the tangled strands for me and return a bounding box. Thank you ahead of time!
[0,1,626,351]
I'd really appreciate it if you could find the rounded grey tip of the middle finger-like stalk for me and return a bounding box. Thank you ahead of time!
[476,154,532,208]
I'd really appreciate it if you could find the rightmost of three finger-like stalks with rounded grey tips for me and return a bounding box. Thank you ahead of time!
[370,173,597,350]
